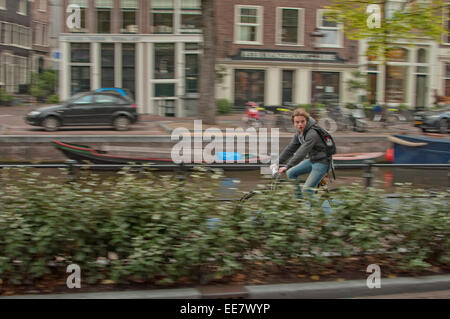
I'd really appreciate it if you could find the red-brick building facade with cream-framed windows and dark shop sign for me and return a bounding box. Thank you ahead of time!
[216,0,358,107]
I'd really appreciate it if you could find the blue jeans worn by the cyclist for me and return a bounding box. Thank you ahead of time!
[286,159,330,196]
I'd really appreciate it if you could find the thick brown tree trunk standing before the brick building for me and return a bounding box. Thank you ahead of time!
[197,0,216,124]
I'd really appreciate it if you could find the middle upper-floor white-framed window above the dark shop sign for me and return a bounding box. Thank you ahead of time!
[277,8,303,45]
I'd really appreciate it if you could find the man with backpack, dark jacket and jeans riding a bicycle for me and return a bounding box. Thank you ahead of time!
[271,109,334,193]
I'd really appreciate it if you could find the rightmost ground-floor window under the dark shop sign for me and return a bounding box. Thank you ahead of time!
[311,71,341,105]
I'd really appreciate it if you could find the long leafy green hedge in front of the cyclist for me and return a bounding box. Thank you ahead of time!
[0,169,450,284]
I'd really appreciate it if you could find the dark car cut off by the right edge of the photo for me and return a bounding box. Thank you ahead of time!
[414,106,450,134]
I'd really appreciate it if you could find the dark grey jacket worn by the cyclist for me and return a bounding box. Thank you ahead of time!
[279,117,330,169]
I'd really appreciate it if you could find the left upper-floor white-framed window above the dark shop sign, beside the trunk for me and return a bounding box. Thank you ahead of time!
[235,6,263,44]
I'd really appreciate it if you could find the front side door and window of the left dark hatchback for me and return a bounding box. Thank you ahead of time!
[61,94,95,125]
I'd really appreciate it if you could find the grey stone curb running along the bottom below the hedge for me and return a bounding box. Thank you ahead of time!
[0,275,450,299]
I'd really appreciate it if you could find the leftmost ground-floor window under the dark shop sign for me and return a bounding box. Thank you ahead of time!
[234,69,265,106]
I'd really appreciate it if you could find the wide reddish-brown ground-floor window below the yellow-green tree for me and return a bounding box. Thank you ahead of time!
[384,65,407,103]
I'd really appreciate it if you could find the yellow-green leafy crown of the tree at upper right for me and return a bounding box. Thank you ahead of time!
[326,0,446,61]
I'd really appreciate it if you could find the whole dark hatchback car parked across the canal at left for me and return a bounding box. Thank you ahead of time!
[25,92,138,131]
